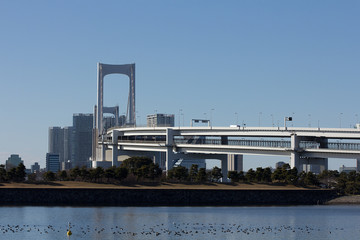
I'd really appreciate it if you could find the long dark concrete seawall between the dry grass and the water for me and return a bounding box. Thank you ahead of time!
[0,188,336,206]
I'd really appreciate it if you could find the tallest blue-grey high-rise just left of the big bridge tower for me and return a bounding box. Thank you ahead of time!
[72,113,93,167]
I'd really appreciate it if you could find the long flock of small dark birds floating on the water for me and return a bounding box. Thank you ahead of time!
[0,223,344,239]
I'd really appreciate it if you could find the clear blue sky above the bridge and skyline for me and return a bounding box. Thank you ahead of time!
[0,0,360,169]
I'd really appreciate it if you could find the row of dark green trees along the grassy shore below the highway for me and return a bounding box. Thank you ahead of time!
[0,157,360,195]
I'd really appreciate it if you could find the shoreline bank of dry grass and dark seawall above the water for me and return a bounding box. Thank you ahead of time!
[0,181,360,206]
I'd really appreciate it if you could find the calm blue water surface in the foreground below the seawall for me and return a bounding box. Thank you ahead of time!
[0,206,360,240]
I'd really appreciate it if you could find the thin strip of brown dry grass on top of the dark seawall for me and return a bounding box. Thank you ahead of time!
[0,181,307,190]
